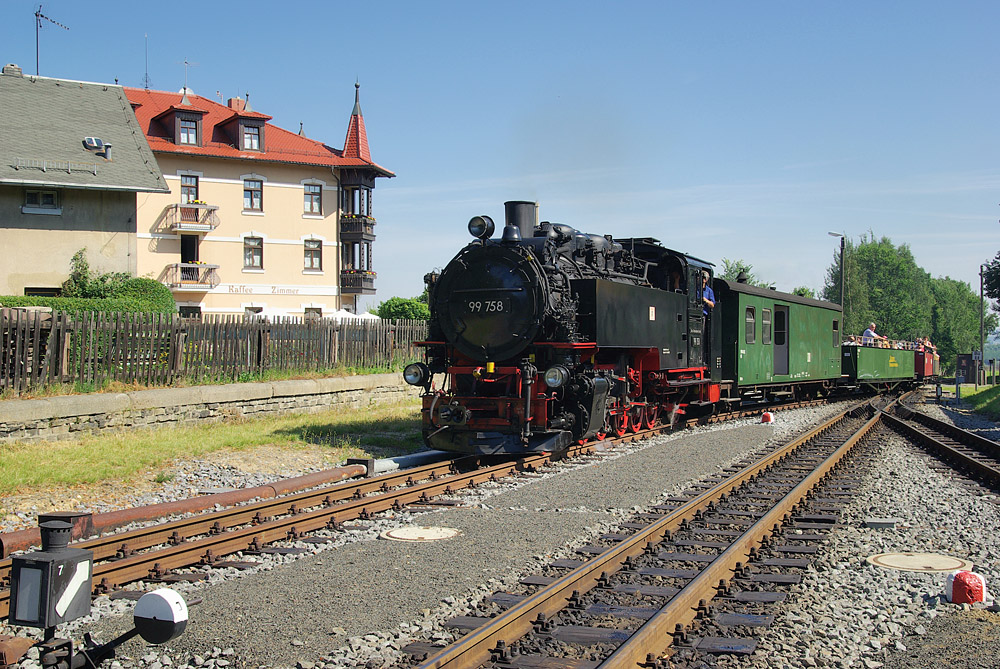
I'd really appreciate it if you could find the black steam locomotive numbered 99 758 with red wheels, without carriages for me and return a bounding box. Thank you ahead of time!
[404,202,721,453]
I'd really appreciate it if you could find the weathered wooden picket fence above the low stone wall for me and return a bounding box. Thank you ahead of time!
[0,309,427,395]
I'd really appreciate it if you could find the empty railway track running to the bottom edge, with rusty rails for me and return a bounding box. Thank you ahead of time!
[404,406,879,669]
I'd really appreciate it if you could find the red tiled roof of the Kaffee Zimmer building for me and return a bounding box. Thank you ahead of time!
[125,88,395,177]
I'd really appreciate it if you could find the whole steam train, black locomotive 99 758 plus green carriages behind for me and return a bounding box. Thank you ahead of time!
[403,201,914,453]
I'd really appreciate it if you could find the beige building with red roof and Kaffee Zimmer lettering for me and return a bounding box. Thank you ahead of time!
[125,82,394,316]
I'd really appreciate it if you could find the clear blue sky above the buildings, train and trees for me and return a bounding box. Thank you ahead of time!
[0,0,1000,314]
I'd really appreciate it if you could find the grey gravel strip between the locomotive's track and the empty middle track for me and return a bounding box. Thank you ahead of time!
[78,412,796,666]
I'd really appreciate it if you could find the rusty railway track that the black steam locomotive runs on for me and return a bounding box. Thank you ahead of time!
[0,400,823,616]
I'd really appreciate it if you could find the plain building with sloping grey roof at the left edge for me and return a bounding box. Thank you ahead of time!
[0,65,169,295]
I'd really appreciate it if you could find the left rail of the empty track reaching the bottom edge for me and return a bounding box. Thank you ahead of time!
[410,404,864,669]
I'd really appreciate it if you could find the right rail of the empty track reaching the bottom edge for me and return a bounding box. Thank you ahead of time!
[599,413,881,669]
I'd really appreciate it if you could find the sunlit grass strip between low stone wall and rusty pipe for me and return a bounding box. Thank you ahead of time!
[0,400,422,496]
